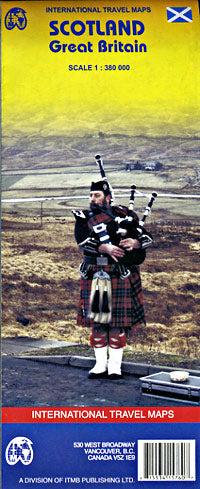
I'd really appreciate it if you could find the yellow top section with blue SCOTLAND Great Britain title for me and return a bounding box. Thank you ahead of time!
[2,0,200,136]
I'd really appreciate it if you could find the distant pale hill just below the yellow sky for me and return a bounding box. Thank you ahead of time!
[2,133,200,171]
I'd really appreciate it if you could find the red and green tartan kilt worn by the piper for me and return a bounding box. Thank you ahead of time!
[77,265,146,329]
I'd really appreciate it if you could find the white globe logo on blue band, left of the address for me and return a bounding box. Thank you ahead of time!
[5,436,33,465]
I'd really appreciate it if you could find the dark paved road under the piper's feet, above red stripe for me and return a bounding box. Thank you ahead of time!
[2,355,187,407]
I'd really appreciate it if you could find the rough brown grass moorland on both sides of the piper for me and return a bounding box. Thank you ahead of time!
[2,213,200,358]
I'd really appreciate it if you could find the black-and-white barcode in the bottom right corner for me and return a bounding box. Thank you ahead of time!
[138,440,196,481]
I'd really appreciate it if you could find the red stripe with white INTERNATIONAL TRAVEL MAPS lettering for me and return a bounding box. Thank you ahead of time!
[2,406,200,423]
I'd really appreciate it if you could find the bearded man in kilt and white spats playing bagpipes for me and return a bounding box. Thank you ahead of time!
[73,179,152,380]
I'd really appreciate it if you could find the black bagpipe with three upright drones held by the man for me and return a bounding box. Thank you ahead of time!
[95,155,157,267]
